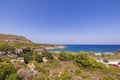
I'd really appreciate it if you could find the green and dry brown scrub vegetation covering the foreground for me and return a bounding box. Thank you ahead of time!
[0,43,120,80]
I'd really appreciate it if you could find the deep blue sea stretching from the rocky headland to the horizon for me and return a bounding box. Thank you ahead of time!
[49,45,120,53]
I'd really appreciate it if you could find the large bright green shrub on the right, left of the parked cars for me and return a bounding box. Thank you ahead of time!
[74,52,109,72]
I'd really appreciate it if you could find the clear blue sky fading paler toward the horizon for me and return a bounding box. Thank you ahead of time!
[0,0,120,44]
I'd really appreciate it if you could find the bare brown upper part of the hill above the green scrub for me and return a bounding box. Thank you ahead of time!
[0,34,32,44]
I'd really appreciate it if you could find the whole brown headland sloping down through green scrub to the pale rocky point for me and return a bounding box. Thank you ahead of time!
[0,34,64,49]
